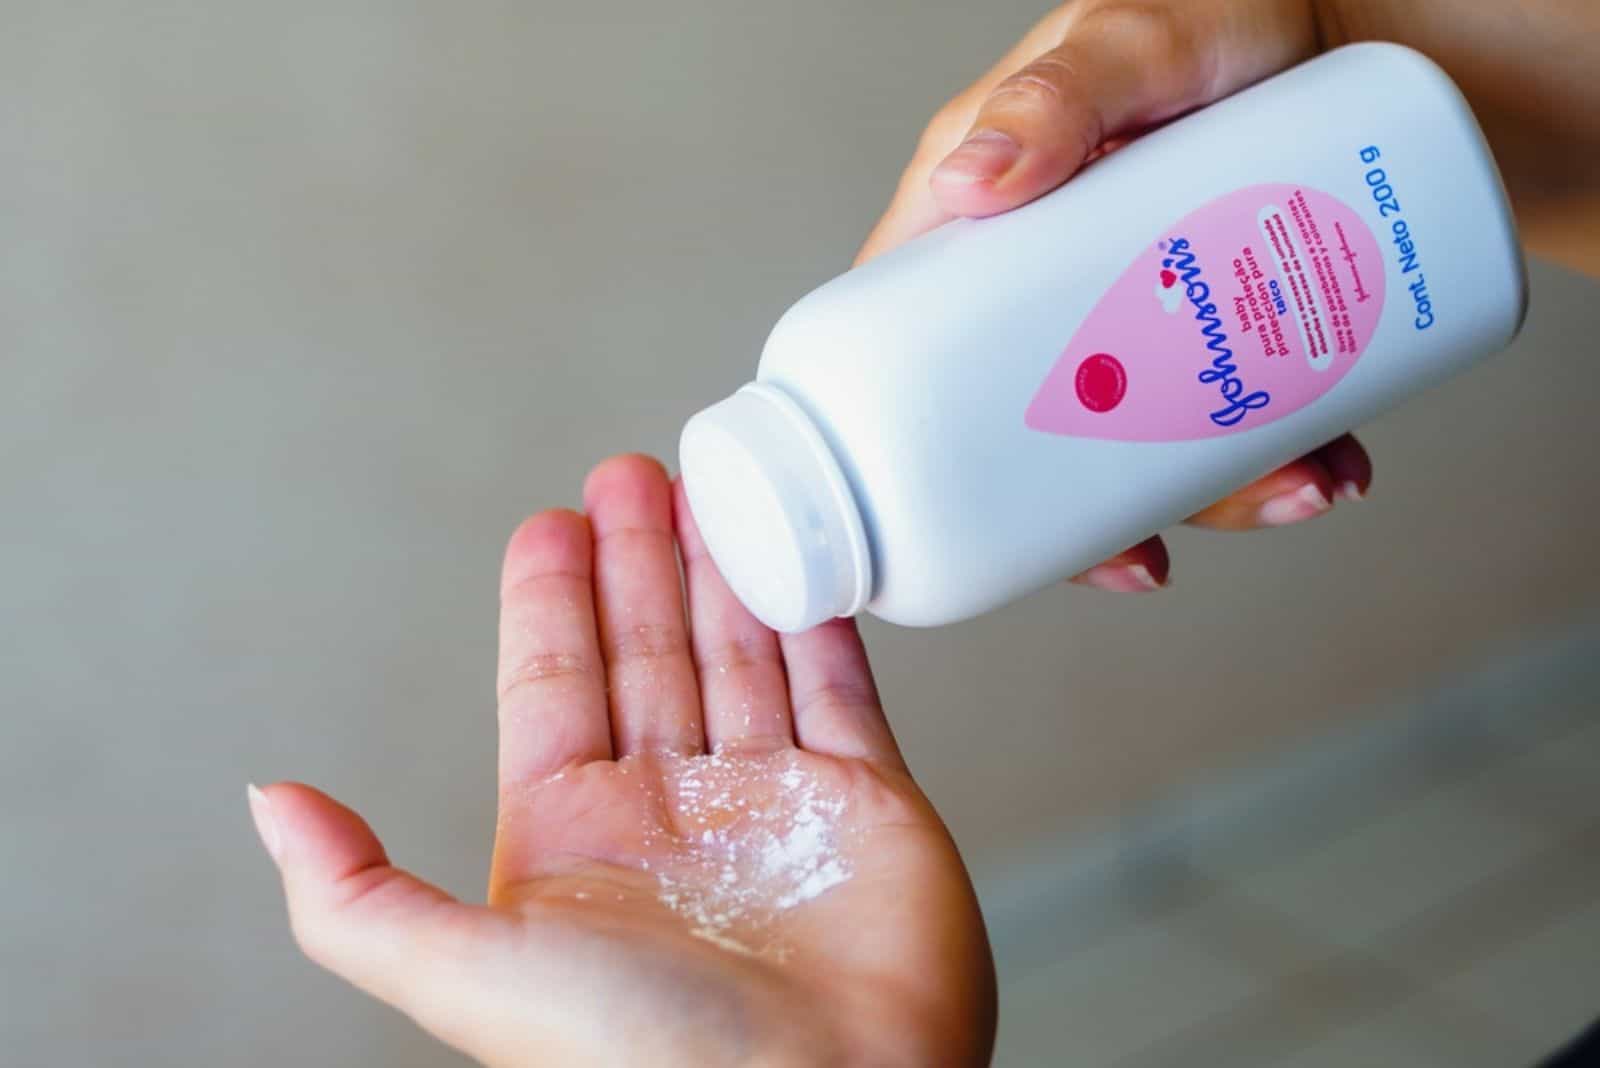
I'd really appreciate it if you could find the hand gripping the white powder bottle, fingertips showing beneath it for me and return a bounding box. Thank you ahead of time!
[858,0,1600,592]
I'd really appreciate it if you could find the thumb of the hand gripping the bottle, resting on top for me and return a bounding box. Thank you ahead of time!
[930,0,1318,216]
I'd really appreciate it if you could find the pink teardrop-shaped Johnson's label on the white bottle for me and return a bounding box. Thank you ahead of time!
[1024,184,1384,441]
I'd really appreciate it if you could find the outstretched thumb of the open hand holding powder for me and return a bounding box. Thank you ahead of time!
[248,783,496,1041]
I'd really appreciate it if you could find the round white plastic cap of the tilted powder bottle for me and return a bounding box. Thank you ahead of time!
[678,382,872,632]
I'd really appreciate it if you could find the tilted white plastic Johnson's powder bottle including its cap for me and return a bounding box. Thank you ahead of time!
[680,43,1526,632]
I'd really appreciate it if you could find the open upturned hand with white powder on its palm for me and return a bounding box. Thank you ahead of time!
[253,457,994,1065]
